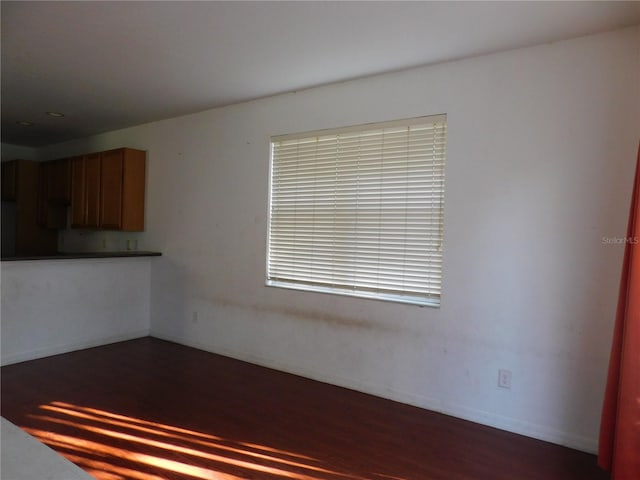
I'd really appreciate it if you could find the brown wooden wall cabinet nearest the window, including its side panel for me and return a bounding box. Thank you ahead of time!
[71,148,146,231]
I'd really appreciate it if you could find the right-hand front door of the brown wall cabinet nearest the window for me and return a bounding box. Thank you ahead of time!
[100,149,124,230]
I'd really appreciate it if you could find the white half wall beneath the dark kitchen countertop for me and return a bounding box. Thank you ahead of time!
[2,257,153,365]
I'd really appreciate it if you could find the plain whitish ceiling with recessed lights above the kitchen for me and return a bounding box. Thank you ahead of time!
[0,1,640,147]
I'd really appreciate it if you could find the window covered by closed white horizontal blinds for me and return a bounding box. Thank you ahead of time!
[267,115,447,306]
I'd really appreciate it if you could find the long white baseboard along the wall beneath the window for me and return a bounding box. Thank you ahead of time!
[151,332,598,453]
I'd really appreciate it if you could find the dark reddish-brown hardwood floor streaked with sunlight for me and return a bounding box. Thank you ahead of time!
[2,338,609,480]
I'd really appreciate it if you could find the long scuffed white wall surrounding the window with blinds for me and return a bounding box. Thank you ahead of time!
[37,27,640,451]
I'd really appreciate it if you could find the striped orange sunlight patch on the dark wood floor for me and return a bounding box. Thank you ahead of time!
[23,402,403,480]
